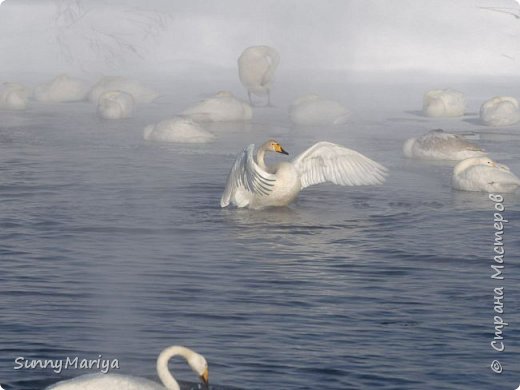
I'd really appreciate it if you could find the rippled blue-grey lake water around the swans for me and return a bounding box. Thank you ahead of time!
[0,77,520,390]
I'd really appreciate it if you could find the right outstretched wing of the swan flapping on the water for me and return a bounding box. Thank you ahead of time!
[293,142,387,188]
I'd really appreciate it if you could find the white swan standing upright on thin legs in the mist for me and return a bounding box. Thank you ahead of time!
[238,46,280,106]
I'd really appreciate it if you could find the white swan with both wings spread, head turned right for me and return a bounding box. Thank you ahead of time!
[220,139,387,209]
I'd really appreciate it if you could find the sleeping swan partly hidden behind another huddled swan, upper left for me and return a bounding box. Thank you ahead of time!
[88,76,159,104]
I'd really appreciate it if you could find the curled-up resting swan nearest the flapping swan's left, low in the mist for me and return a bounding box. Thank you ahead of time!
[144,117,215,143]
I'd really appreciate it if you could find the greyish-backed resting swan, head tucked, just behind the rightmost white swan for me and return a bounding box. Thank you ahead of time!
[403,129,486,160]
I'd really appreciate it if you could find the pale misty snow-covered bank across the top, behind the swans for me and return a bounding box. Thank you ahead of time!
[0,0,520,81]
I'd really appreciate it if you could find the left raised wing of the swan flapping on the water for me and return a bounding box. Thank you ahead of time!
[220,144,276,207]
